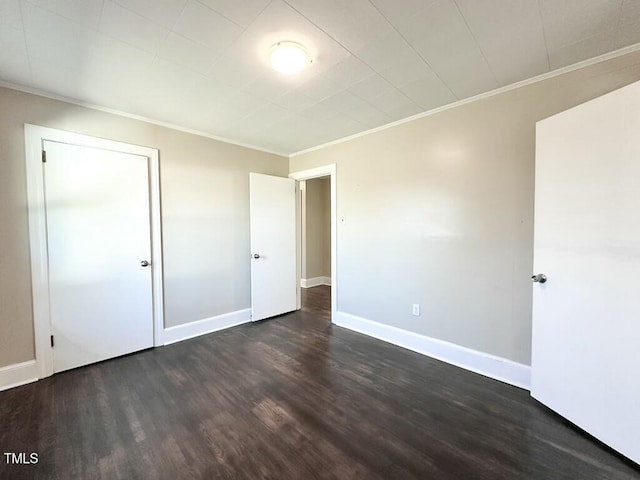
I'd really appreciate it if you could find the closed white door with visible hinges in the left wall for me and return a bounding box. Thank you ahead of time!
[43,141,153,372]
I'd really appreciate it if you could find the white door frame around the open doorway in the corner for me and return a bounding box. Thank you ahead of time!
[289,163,338,323]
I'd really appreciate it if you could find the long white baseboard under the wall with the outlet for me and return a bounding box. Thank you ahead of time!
[335,312,531,390]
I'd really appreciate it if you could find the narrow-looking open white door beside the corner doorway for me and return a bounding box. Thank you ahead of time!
[249,173,296,322]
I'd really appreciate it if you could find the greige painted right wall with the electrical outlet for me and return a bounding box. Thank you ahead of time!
[290,49,640,364]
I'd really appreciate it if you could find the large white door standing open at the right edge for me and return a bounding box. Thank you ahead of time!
[531,83,640,463]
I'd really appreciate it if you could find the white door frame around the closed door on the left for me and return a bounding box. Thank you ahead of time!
[24,124,164,378]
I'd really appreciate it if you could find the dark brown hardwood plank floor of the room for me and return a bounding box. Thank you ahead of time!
[0,287,640,480]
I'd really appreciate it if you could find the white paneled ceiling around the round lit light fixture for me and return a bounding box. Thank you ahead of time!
[0,0,640,154]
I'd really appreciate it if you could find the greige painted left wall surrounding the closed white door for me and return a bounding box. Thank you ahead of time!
[0,88,288,367]
